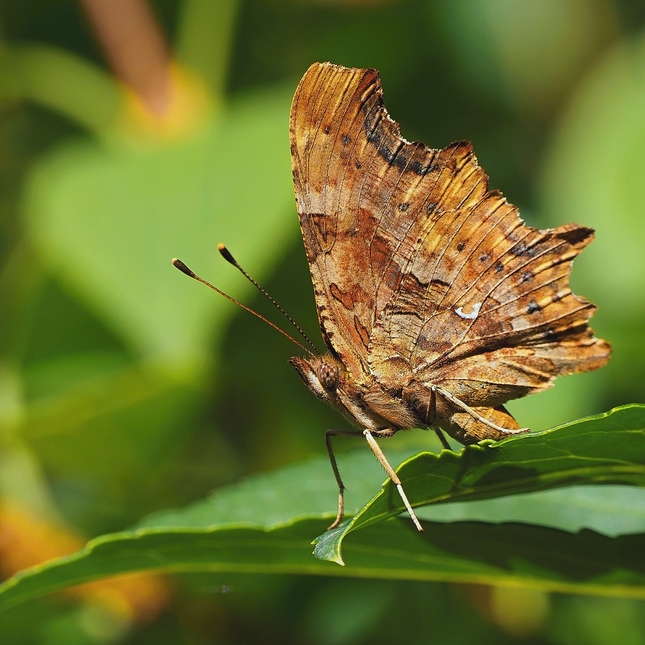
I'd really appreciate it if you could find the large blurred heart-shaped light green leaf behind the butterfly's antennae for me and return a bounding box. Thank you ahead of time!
[26,84,297,369]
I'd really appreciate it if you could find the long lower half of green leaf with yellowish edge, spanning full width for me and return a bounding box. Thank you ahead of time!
[0,519,645,609]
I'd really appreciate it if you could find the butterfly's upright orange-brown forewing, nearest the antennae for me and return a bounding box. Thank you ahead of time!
[290,63,459,382]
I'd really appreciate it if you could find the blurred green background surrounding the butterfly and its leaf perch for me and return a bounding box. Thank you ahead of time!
[0,0,645,645]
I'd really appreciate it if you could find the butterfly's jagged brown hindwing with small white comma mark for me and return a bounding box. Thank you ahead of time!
[358,103,610,407]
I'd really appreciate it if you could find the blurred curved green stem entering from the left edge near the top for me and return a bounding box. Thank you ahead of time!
[0,45,120,132]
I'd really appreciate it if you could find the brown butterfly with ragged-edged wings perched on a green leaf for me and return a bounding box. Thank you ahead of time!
[290,63,611,530]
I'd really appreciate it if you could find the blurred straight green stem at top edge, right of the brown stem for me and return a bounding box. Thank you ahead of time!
[176,0,238,104]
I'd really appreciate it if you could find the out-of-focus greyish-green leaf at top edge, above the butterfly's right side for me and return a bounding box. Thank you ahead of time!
[428,0,617,117]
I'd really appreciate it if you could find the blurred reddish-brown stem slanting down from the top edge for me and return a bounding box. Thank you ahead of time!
[81,0,172,116]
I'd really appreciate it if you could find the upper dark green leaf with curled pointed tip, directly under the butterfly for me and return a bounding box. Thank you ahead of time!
[316,405,645,564]
